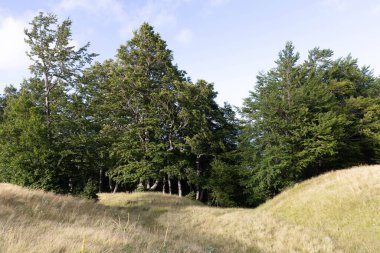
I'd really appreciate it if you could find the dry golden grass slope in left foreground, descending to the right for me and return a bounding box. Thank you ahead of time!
[0,184,207,253]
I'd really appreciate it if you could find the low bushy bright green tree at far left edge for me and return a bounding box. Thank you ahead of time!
[0,87,52,190]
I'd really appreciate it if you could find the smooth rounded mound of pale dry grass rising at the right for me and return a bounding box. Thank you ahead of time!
[257,165,380,252]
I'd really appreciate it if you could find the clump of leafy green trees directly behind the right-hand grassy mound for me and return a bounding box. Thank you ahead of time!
[241,43,378,205]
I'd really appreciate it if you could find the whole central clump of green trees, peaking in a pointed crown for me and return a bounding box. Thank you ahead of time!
[94,23,242,203]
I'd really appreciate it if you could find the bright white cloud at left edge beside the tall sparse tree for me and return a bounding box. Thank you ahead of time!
[0,16,29,71]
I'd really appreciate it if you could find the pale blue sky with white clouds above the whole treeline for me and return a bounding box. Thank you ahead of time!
[0,0,380,106]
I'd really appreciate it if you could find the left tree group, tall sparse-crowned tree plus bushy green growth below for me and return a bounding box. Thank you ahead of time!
[0,13,95,193]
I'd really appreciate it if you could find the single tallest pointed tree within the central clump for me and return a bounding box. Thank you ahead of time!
[105,23,184,192]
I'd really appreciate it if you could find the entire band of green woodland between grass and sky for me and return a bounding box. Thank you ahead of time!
[0,13,380,206]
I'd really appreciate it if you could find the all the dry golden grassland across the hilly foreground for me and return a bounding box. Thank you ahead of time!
[0,166,380,252]
